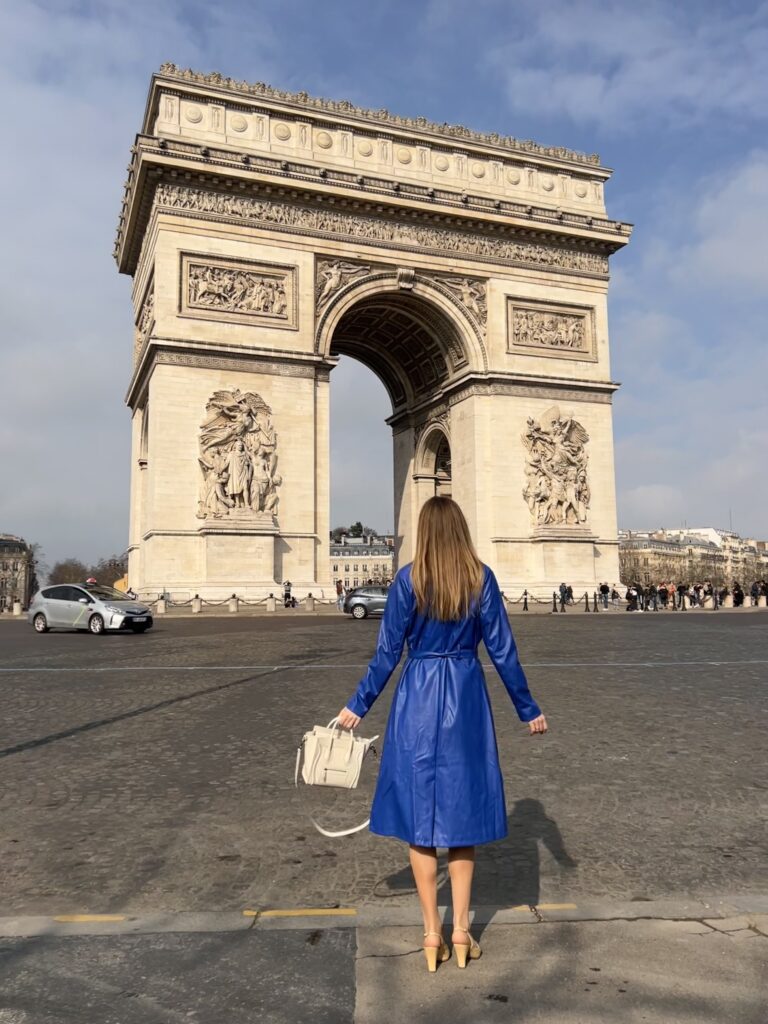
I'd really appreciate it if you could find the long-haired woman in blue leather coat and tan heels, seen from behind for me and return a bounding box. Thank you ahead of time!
[339,497,547,972]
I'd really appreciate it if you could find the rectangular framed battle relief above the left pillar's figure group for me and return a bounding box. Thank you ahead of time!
[179,253,297,329]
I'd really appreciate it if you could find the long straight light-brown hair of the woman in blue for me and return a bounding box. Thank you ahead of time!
[411,498,483,622]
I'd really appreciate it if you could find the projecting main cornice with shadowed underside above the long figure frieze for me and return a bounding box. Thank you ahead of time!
[115,141,631,278]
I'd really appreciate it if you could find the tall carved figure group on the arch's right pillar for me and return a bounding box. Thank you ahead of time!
[522,406,591,526]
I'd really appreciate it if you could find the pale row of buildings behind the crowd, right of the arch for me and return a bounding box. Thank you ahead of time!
[618,526,768,587]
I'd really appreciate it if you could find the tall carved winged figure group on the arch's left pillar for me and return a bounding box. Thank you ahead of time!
[197,388,283,520]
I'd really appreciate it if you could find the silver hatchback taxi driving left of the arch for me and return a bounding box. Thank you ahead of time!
[27,583,153,635]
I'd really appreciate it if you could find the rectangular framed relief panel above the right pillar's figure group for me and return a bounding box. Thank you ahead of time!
[507,298,597,361]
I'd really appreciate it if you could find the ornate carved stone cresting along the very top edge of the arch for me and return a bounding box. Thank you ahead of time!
[153,62,601,168]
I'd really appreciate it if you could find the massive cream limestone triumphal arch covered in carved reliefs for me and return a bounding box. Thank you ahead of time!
[115,65,630,599]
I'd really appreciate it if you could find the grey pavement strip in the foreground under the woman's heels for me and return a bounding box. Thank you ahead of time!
[0,897,768,1024]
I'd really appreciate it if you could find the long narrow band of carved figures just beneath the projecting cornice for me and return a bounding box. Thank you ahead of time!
[155,182,608,278]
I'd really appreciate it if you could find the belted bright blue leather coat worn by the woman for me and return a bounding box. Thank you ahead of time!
[347,565,541,847]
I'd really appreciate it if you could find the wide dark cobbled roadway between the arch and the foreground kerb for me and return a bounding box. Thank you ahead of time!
[0,610,768,915]
